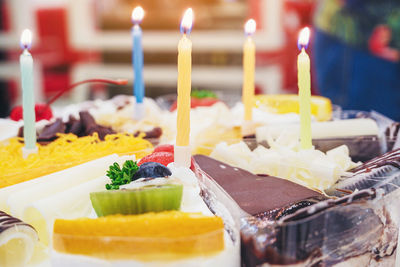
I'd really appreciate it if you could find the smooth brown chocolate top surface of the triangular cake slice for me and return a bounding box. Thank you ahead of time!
[194,155,326,215]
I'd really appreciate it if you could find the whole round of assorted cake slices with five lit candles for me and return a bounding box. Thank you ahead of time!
[5,7,400,267]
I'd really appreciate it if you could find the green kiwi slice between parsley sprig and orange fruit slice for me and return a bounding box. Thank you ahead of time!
[90,184,183,217]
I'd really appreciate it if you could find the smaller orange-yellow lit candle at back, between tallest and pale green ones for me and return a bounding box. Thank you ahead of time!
[242,19,256,121]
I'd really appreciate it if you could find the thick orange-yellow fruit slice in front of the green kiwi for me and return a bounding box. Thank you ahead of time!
[53,211,224,260]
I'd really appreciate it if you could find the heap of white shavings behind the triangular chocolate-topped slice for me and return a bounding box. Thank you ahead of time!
[210,141,356,191]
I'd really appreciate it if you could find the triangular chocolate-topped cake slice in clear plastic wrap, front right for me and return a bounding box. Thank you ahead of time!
[195,154,400,267]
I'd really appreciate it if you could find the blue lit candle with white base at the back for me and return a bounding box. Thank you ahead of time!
[132,6,144,120]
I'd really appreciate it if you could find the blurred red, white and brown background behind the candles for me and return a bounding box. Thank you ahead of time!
[0,0,315,117]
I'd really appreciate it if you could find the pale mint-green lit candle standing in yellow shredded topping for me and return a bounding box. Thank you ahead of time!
[19,29,37,157]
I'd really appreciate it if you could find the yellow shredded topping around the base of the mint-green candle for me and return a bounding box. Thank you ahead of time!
[0,133,153,188]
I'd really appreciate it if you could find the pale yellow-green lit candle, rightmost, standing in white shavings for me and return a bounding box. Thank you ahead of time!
[297,27,312,149]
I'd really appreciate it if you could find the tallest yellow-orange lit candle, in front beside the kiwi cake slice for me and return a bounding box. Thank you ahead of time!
[175,8,193,167]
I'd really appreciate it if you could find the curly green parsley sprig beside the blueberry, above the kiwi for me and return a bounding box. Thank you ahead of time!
[106,160,139,190]
